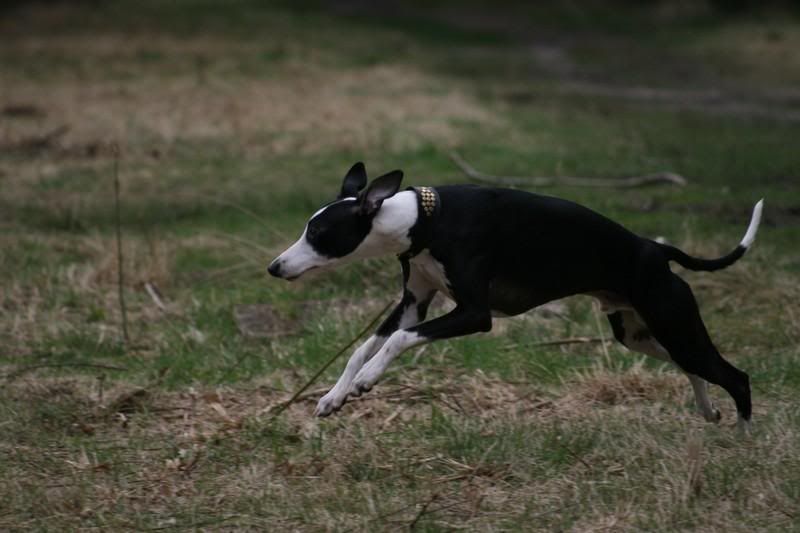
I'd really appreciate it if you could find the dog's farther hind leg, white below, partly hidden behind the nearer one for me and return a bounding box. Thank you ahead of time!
[608,309,720,422]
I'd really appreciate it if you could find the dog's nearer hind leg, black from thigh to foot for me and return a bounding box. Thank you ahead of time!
[632,270,752,431]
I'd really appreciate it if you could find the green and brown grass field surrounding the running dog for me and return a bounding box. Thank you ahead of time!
[0,0,800,531]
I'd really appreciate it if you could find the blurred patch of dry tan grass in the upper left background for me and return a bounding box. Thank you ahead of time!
[0,29,498,170]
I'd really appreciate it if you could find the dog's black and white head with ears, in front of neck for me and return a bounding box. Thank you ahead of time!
[267,162,403,280]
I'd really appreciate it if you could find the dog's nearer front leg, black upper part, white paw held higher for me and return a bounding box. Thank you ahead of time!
[353,306,492,394]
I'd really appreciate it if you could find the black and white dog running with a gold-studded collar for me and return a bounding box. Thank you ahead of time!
[269,163,763,430]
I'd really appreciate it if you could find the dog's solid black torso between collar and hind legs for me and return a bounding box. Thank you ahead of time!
[430,185,644,315]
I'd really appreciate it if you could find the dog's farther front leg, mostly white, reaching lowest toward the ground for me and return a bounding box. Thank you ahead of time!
[314,261,436,416]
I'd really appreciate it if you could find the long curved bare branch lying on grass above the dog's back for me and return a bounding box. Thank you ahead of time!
[450,152,687,189]
